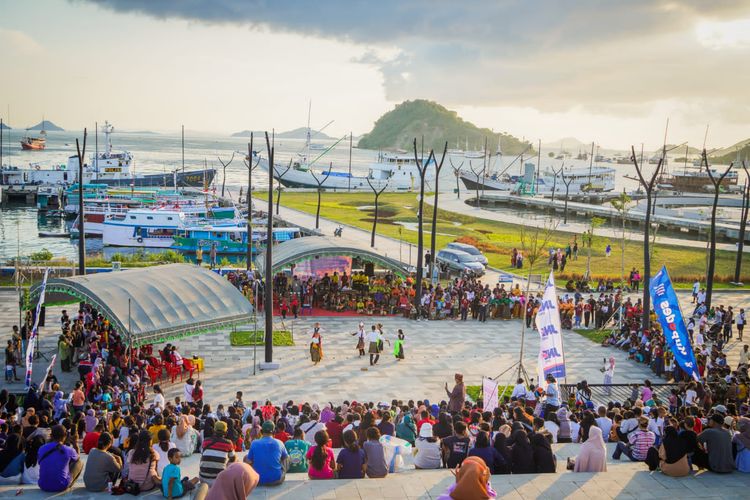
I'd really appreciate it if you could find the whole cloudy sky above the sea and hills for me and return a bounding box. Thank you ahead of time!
[0,0,750,148]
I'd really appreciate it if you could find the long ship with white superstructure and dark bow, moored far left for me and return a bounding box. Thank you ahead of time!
[0,122,216,189]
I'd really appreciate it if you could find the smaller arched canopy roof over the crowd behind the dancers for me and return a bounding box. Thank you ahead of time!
[257,236,409,276]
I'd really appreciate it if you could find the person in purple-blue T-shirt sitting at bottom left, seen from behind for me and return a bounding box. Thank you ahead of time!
[37,425,83,493]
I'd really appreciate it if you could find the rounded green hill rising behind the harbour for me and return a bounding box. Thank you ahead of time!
[357,99,534,155]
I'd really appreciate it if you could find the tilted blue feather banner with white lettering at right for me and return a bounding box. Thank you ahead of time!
[649,266,700,380]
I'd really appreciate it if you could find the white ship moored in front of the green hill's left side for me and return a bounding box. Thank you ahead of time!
[260,153,434,191]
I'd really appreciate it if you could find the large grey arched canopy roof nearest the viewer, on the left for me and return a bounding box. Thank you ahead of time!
[31,264,252,346]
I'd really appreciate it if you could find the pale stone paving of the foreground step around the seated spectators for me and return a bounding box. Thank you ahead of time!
[0,444,750,500]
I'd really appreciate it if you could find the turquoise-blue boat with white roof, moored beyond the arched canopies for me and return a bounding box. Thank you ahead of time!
[172,224,302,255]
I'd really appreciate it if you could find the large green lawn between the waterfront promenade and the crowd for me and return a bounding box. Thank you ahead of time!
[281,192,750,288]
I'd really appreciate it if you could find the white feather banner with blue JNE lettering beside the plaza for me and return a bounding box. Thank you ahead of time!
[536,271,565,384]
